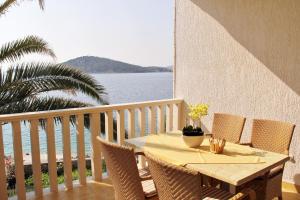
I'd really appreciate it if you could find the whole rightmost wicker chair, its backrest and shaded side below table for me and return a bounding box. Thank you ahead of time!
[248,119,295,200]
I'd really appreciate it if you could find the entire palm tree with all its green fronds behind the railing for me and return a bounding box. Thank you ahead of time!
[0,0,107,114]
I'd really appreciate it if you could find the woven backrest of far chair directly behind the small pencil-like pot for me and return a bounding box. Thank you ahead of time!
[212,113,246,143]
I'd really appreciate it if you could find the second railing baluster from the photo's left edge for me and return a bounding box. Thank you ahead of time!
[12,121,26,200]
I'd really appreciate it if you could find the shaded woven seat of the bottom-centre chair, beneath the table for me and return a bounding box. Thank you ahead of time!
[202,187,234,200]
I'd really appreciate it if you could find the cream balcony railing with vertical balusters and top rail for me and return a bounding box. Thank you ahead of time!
[0,99,184,200]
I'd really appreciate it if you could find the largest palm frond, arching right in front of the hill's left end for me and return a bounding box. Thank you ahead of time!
[0,63,107,105]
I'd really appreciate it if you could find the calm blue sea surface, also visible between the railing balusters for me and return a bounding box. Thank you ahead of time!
[3,73,173,155]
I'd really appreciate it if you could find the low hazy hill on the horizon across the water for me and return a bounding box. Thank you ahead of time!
[64,56,172,73]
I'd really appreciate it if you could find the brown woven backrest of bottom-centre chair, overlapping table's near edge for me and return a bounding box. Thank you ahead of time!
[145,152,202,200]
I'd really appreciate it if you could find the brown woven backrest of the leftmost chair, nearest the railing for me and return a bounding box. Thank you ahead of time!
[97,137,145,200]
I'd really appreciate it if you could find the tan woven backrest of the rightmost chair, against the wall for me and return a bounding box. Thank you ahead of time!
[251,119,295,154]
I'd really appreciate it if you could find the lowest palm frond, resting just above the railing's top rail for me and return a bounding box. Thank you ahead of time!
[0,97,91,114]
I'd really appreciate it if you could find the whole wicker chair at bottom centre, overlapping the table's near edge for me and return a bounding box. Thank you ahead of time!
[145,153,256,200]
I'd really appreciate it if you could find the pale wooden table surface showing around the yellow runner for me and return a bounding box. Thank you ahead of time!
[125,133,289,193]
